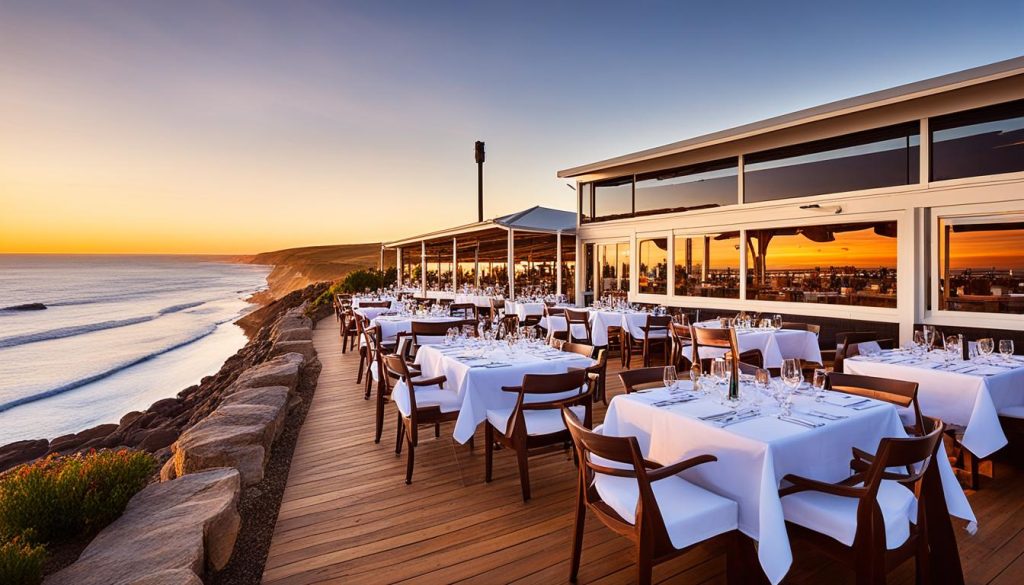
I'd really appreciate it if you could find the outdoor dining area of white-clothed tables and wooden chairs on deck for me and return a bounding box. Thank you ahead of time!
[299,292,1024,583]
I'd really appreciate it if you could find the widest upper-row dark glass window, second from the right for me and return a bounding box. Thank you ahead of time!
[743,123,921,203]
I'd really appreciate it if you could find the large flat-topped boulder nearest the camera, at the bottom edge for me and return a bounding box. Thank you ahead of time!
[44,468,241,585]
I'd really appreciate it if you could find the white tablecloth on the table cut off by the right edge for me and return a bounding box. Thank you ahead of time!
[843,351,1024,457]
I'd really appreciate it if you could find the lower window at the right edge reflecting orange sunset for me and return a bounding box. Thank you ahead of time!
[939,220,1024,315]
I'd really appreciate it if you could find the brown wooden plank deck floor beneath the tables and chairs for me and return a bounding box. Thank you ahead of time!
[263,318,1024,585]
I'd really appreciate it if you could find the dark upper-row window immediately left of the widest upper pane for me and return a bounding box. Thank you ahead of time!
[635,159,737,215]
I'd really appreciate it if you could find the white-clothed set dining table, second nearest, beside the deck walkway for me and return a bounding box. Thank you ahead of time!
[416,341,595,443]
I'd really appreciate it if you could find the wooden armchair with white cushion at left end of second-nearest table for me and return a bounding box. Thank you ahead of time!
[384,354,460,484]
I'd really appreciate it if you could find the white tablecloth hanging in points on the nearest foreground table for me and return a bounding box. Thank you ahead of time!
[603,381,975,583]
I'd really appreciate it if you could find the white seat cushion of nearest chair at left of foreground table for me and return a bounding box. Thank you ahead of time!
[593,457,739,549]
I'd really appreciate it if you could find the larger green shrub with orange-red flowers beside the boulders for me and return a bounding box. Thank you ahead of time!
[0,450,156,543]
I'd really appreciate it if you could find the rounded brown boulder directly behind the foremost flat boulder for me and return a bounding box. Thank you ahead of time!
[161,401,287,486]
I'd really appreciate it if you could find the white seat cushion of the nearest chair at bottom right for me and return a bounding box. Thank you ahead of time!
[782,479,918,549]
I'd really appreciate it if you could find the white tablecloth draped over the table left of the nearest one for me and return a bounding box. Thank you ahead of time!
[416,346,594,443]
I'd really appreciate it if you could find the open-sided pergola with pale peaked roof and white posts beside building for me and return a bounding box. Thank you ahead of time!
[381,206,577,298]
